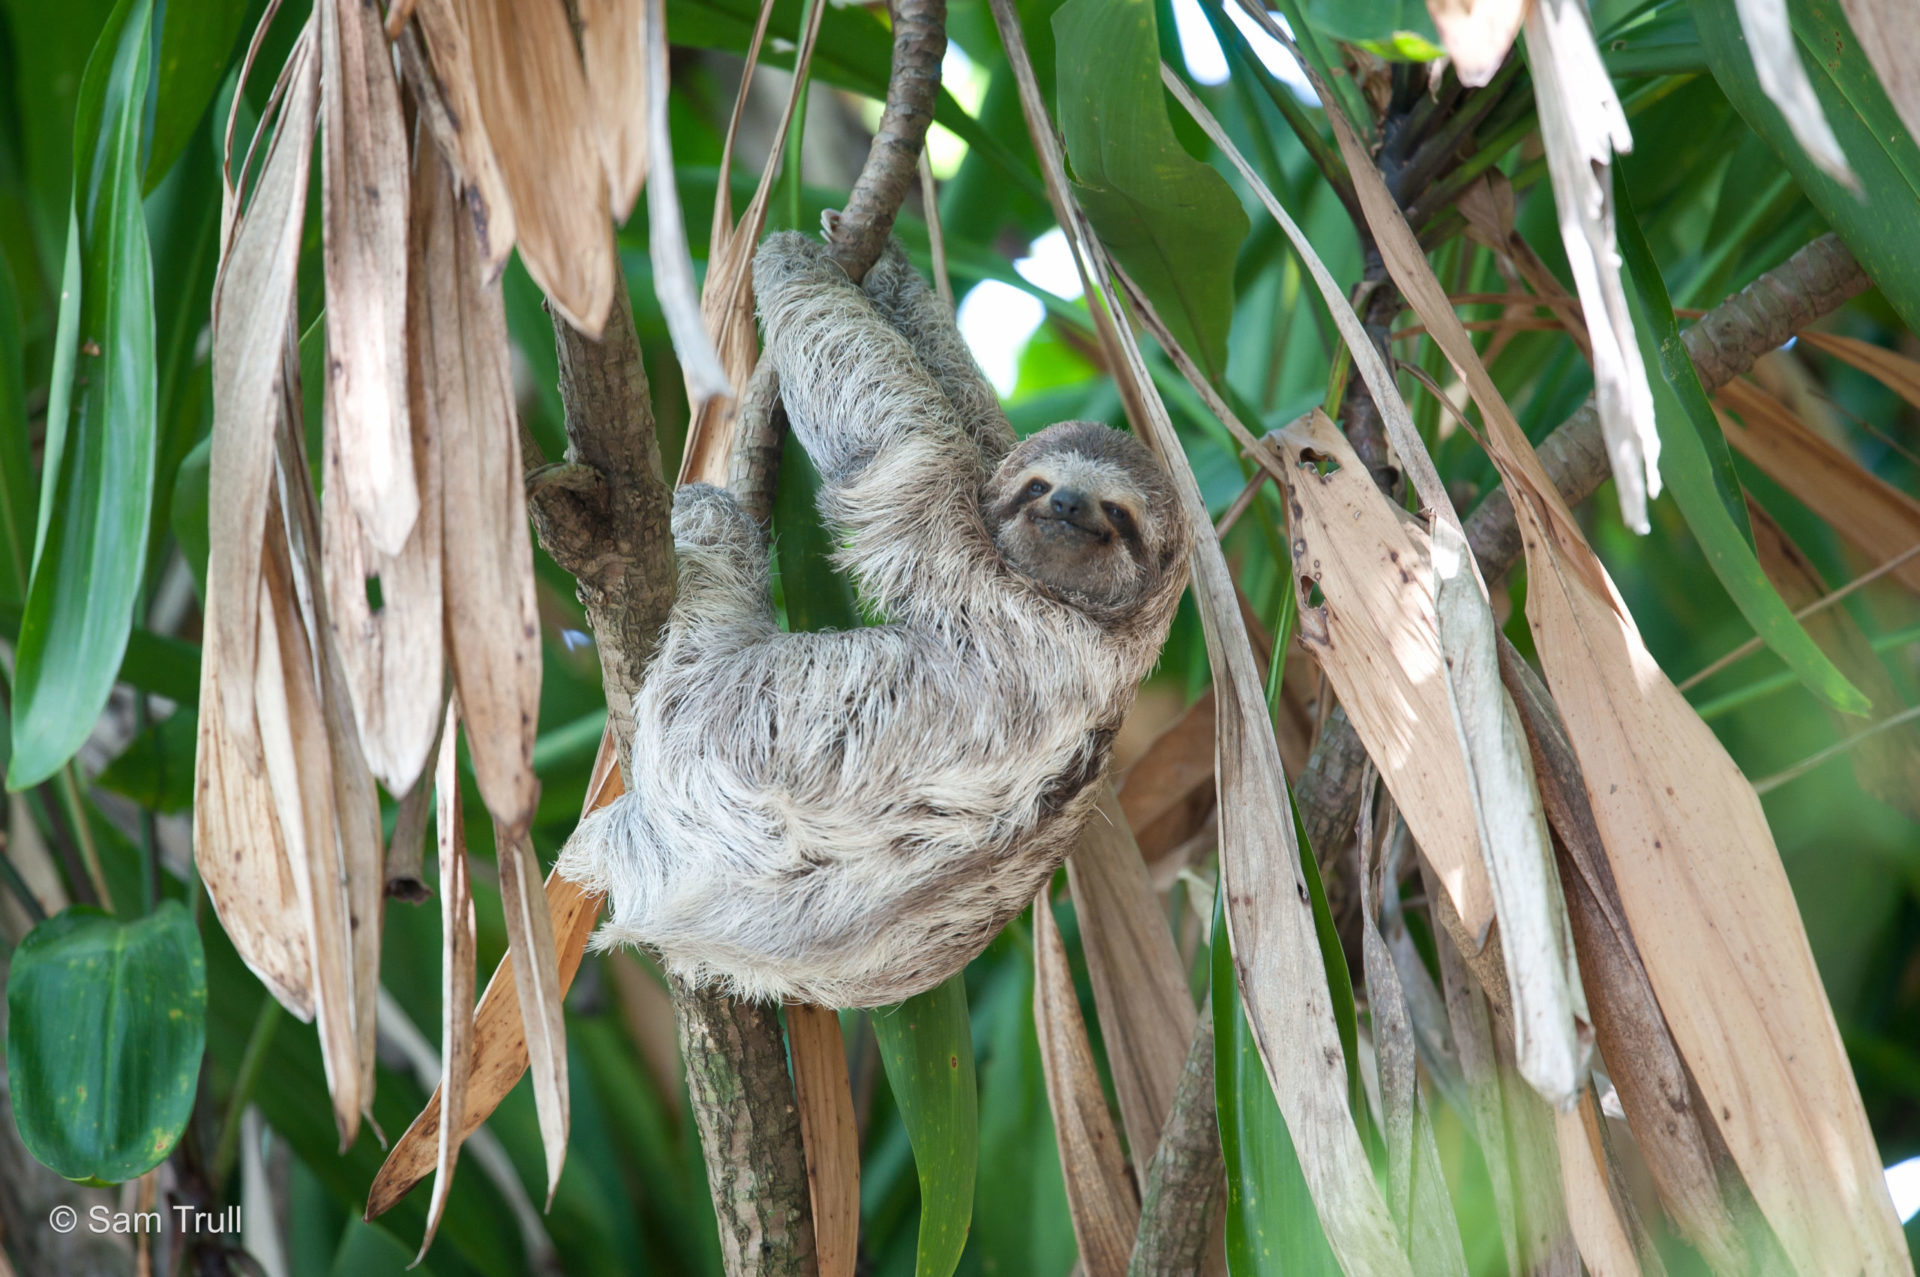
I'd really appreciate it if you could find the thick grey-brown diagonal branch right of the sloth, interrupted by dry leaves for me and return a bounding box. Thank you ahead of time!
[1294,234,1868,933]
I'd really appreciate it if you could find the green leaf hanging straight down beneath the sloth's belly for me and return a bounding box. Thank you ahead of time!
[872,974,979,1277]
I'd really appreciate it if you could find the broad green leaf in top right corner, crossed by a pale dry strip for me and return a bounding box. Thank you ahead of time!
[1693,0,1920,332]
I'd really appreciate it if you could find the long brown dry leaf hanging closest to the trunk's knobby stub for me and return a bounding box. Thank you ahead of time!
[413,146,540,828]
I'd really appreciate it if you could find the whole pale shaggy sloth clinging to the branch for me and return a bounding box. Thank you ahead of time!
[559,232,1188,1006]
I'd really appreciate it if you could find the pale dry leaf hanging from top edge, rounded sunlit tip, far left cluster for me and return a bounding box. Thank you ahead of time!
[319,0,420,555]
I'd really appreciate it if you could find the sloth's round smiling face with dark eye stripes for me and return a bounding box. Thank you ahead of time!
[983,421,1185,613]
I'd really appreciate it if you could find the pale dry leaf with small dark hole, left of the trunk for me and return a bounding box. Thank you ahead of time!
[321,144,445,793]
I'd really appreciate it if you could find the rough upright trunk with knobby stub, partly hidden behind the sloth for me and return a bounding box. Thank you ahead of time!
[526,270,814,1277]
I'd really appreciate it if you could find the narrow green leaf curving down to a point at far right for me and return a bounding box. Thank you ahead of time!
[1613,169,1870,714]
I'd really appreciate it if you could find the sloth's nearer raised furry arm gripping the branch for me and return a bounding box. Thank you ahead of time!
[753,232,998,618]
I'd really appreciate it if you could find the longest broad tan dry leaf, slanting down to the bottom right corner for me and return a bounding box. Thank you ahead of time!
[1329,87,1907,1273]
